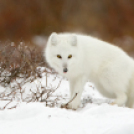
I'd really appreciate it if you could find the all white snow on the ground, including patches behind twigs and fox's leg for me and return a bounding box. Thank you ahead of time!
[0,69,134,134]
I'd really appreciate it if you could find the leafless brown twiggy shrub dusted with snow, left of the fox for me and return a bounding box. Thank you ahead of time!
[0,42,60,110]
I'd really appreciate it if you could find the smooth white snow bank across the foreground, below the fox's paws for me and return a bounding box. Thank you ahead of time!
[0,103,134,134]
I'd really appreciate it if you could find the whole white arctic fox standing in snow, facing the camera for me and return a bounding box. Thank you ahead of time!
[44,33,134,109]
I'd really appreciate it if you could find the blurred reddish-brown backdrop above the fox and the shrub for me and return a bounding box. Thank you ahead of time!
[0,0,134,56]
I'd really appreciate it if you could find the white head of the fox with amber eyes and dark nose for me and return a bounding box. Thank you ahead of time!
[45,33,78,75]
